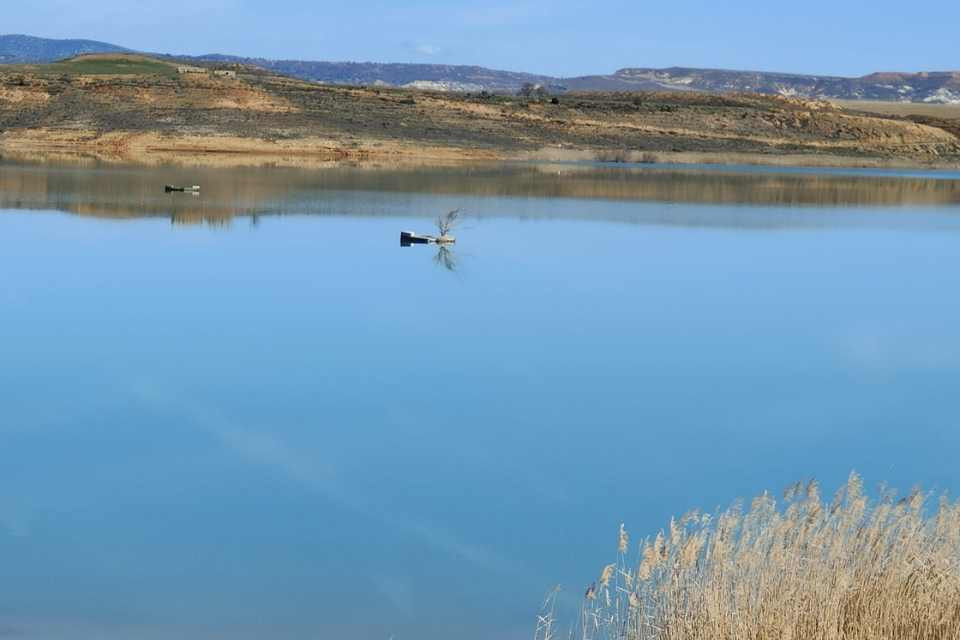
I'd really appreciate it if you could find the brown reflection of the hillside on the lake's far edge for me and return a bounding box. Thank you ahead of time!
[0,164,960,224]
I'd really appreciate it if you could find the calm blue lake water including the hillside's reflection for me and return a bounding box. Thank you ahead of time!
[0,164,960,640]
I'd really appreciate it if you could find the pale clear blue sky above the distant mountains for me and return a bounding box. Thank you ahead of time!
[7,0,960,75]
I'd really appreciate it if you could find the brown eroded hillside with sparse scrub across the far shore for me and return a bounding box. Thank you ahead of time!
[0,55,960,165]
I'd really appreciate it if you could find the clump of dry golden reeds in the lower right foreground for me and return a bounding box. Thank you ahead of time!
[560,474,960,640]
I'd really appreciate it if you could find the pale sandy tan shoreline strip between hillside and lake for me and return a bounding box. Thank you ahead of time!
[0,130,960,171]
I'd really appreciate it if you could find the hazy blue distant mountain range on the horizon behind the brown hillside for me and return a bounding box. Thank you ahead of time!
[0,35,960,104]
